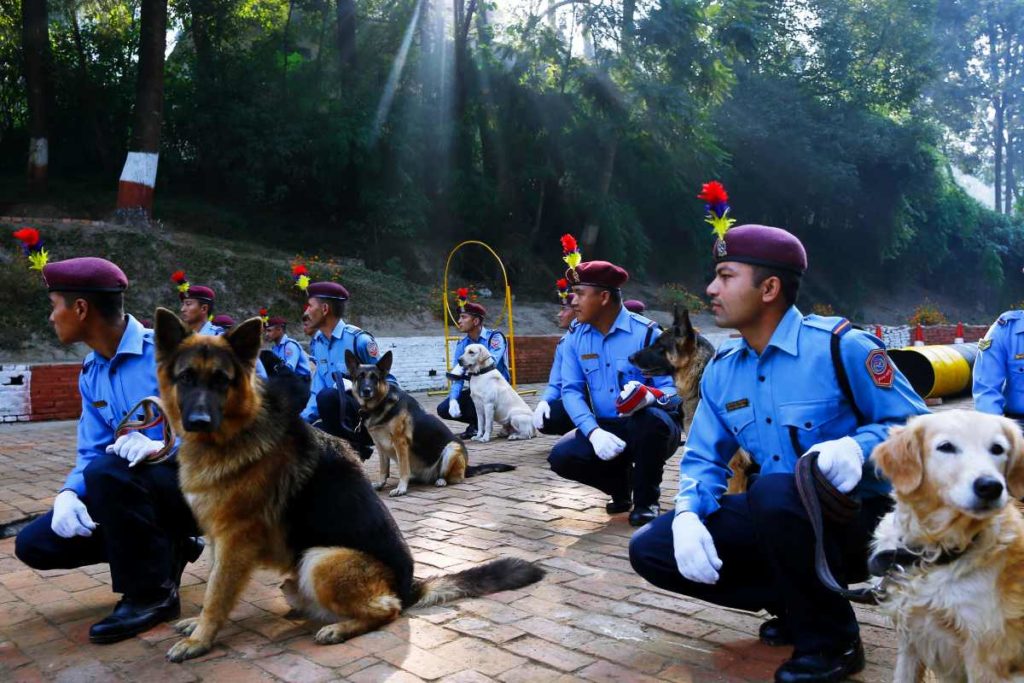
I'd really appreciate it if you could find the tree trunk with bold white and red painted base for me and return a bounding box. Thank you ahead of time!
[118,0,167,216]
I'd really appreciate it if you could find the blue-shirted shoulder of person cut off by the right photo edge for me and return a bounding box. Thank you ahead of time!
[974,310,1024,422]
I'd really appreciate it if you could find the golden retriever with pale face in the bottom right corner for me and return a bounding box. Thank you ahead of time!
[871,410,1024,683]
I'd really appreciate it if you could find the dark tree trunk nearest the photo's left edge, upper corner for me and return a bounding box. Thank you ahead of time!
[22,0,50,191]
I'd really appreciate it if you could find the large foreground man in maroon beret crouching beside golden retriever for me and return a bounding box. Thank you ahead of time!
[630,225,927,683]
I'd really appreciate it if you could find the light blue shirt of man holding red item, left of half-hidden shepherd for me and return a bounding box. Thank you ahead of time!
[561,308,676,436]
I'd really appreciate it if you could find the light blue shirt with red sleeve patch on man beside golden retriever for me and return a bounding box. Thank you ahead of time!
[676,307,928,519]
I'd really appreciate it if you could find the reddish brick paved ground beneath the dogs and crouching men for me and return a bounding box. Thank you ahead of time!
[0,387,966,683]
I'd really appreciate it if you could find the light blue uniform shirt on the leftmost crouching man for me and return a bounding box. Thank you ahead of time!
[63,315,163,498]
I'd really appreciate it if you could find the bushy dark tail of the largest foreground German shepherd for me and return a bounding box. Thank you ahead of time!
[413,557,544,607]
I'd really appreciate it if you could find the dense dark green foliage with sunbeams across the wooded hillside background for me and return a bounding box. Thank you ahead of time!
[0,0,1024,311]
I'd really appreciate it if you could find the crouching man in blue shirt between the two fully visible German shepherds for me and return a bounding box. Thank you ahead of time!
[302,283,398,460]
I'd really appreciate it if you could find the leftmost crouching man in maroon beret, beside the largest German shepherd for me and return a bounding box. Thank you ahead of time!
[14,258,202,643]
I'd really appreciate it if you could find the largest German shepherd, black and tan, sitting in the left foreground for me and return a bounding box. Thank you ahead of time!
[150,308,544,661]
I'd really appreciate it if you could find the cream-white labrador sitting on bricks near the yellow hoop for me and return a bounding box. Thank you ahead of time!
[457,344,537,442]
